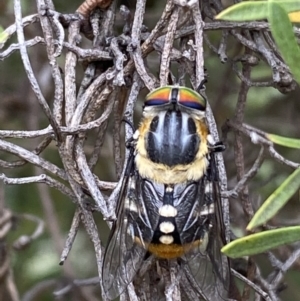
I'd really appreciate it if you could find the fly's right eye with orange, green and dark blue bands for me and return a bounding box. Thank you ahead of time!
[178,87,206,111]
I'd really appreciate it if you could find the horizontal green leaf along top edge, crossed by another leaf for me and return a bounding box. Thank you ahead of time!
[215,0,300,23]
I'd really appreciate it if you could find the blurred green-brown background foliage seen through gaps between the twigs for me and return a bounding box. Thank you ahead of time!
[0,0,300,301]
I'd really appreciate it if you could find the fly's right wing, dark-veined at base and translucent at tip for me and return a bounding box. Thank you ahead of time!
[176,154,230,301]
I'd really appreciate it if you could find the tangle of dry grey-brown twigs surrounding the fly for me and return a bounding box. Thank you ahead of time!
[0,0,299,300]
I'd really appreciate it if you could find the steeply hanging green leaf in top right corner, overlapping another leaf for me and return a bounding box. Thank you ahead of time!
[268,1,300,84]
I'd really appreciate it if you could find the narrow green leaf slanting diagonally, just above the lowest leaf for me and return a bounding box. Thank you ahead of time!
[247,167,300,229]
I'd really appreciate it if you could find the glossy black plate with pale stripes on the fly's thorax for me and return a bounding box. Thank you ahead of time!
[145,110,200,166]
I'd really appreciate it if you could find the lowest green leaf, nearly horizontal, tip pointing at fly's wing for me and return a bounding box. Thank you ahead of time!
[221,226,300,258]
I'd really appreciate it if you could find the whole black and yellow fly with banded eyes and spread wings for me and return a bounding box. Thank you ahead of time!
[102,86,229,300]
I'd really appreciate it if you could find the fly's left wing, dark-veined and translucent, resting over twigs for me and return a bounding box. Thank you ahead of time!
[102,167,158,300]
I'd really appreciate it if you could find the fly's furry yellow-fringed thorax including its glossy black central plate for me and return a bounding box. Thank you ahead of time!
[135,109,209,184]
